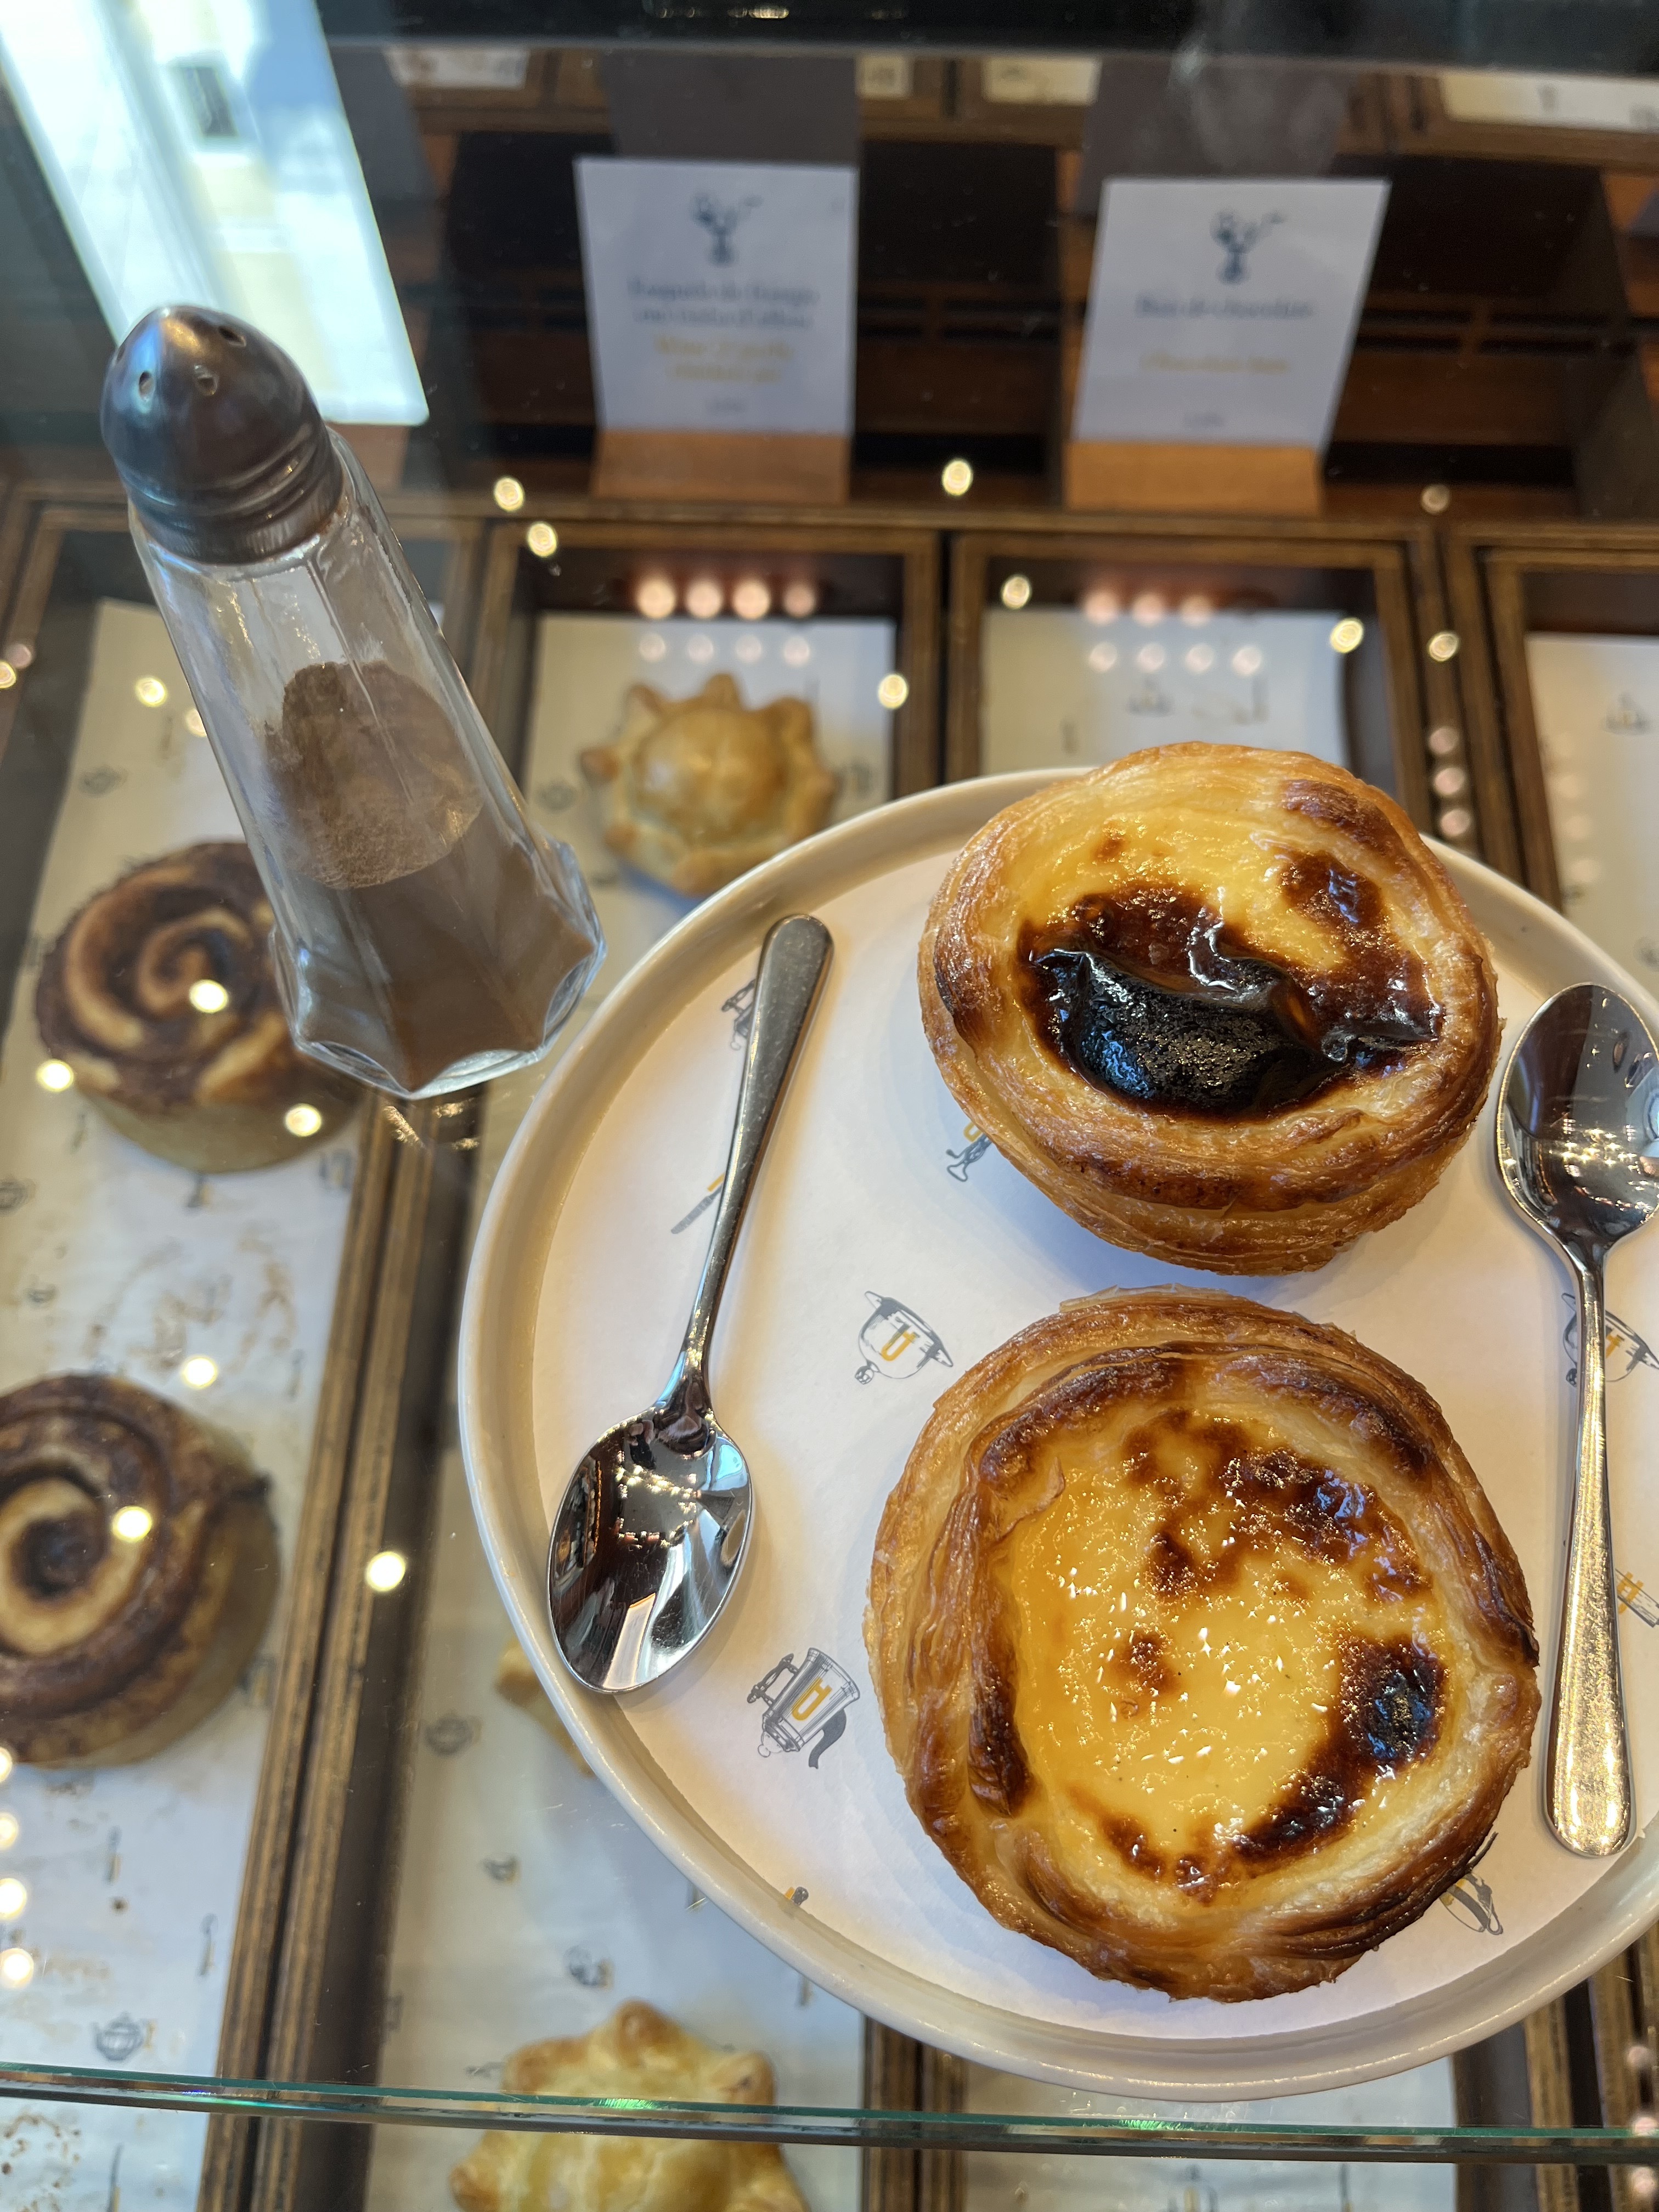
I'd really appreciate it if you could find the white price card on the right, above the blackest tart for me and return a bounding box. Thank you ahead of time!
[1070,177,1389,449]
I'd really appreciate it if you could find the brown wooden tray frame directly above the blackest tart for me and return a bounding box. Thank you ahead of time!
[945,515,1487,851]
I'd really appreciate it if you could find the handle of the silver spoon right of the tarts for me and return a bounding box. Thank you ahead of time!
[1544,1252,1630,1858]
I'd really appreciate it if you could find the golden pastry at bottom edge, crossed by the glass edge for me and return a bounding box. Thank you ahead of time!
[449,2004,808,2212]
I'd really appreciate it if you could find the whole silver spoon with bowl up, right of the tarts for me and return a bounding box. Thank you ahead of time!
[1498,982,1659,1858]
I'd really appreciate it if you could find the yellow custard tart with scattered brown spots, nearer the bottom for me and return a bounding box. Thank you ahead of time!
[865,1292,1537,2000]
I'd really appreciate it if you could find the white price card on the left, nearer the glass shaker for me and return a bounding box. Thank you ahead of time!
[575,159,858,438]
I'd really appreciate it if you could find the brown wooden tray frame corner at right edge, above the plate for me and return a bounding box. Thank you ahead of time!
[1447,522,1659,907]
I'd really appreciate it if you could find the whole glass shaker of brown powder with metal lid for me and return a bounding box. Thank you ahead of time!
[99,307,604,1097]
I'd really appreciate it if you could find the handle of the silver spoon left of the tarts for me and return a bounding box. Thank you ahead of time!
[670,913,834,1391]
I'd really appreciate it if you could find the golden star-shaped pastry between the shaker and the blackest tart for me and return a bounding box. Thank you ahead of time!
[582,675,836,898]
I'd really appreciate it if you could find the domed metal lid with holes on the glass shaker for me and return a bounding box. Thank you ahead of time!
[97,307,343,566]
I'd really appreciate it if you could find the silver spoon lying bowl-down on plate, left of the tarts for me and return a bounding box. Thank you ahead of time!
[546,913,832,1690]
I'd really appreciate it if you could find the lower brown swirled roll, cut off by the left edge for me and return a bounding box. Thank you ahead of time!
[0,1374,276,1768]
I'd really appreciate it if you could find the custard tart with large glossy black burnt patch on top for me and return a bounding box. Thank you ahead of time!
[918,746,1500,1274]
